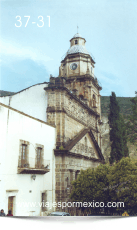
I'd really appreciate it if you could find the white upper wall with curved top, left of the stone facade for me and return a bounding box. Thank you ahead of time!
[0,83,47,121]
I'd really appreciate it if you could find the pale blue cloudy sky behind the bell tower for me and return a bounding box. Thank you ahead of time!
[0,0,137,97]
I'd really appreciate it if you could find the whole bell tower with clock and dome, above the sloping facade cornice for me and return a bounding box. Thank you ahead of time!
[59,33,102,114]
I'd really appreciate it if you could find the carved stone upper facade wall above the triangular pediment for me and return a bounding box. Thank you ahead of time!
[47,89,100,146]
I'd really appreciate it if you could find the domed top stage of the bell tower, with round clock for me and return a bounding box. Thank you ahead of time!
[59,33,95,77]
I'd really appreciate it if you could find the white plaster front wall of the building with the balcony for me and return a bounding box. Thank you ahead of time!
[0,105,55,216]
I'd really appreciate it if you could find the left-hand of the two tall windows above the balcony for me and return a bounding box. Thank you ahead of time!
[18,140,29,168]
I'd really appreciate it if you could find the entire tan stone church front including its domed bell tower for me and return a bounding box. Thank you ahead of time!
[44,33,104,211]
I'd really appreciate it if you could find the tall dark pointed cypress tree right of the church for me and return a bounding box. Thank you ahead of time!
[108,92,129,164]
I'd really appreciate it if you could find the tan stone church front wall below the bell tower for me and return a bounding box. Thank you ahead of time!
[47,88,103,214]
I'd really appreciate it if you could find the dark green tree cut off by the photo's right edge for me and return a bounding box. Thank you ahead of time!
[126,95,137,144]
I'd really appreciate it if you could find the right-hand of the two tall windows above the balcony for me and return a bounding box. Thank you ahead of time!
[35,144,44,168]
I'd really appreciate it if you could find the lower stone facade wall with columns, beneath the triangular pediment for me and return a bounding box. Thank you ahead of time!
[55,154,99,211]
